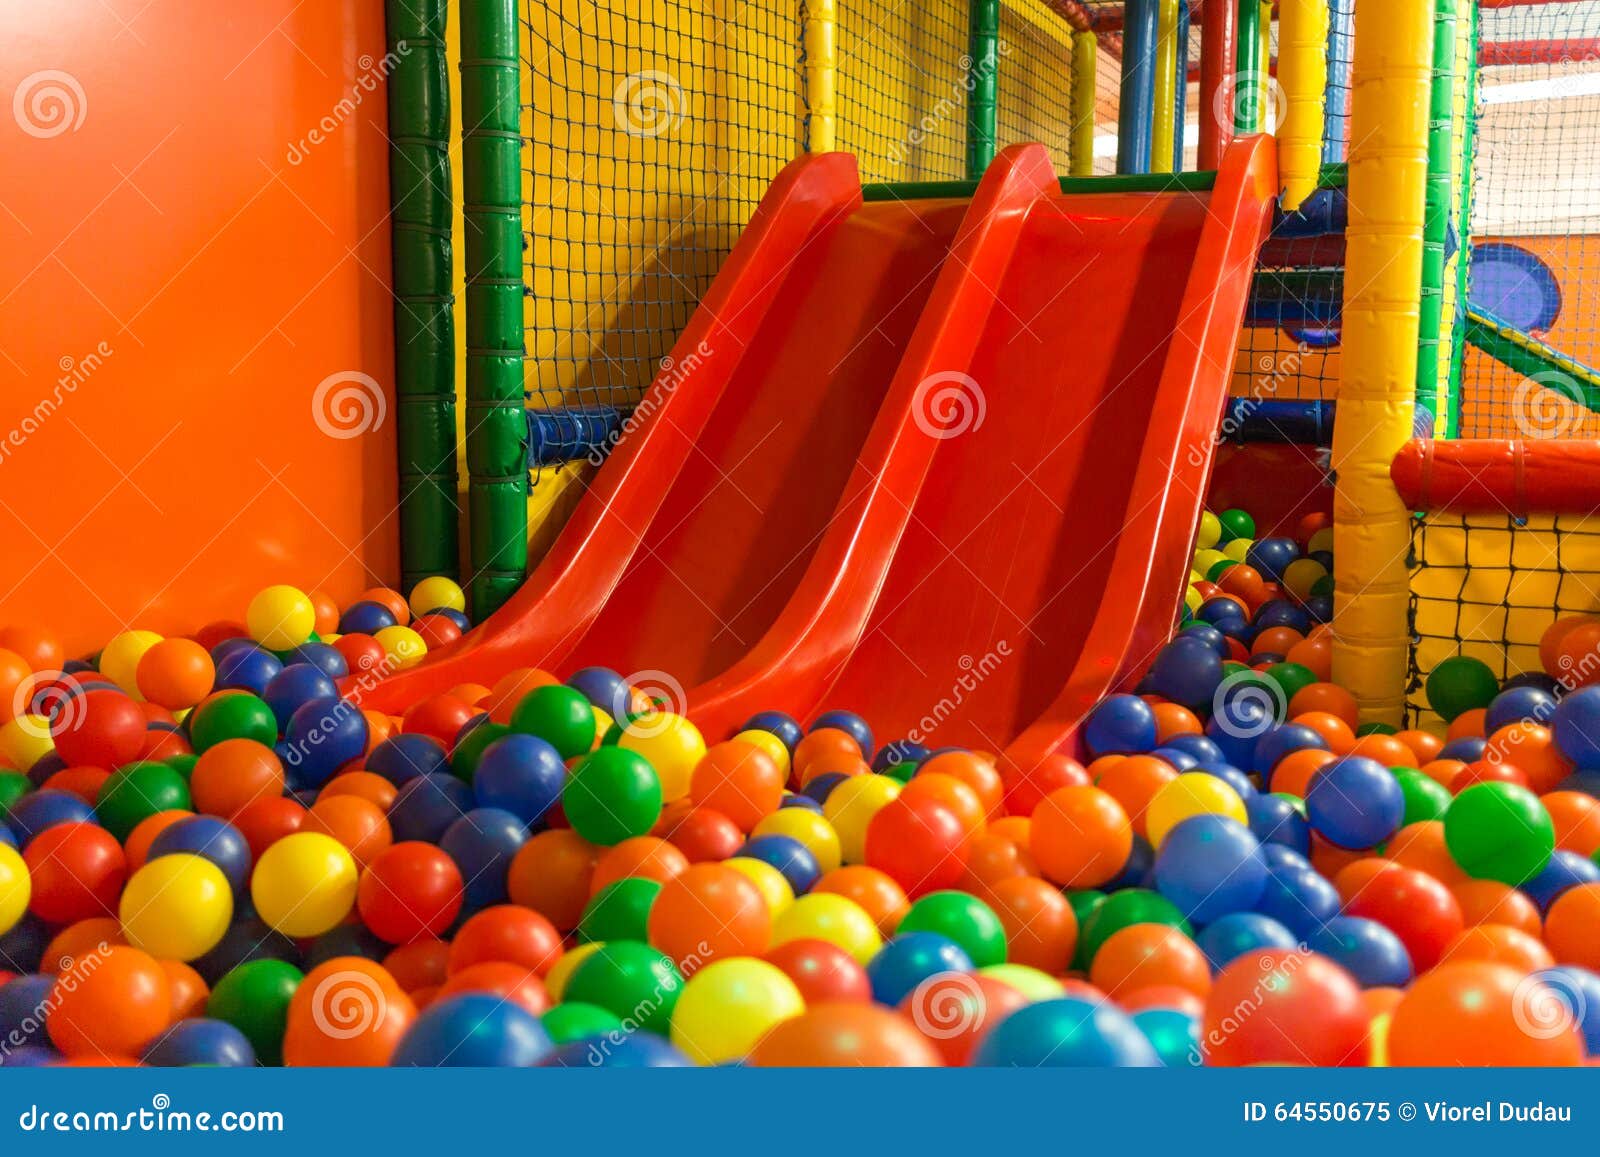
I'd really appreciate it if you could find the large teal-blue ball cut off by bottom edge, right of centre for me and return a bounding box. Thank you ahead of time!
[971,997,1162,1069]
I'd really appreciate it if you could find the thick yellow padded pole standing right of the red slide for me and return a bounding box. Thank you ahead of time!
[1333,0,1434,727]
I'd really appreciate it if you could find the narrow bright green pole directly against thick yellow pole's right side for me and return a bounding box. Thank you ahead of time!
[1416,0,1456,432]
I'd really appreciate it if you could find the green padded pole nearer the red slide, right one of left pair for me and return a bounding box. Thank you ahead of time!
[461,0,528,619]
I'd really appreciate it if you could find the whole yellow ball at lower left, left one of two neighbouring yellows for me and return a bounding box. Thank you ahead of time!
[117,853,234,960]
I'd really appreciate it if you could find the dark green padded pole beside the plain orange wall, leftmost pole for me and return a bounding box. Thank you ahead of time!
[386,0,461,591]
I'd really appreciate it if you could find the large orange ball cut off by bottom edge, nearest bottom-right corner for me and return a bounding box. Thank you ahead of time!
[1389,960,1584,1067]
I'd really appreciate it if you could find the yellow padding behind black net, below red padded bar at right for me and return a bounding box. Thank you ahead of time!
[1411,515,1600,723]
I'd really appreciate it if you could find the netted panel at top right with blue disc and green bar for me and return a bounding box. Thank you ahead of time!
[1461,0,1600,438]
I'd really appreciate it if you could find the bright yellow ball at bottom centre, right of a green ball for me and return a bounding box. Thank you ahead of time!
[672,957,805,1064]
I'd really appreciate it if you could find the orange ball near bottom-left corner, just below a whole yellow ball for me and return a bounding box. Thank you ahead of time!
[45,946,173,1058]
